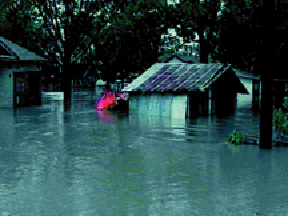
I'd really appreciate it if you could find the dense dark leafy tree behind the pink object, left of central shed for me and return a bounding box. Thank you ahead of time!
[79,0,173,89]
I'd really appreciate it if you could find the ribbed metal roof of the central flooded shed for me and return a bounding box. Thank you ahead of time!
[122,63,249,94]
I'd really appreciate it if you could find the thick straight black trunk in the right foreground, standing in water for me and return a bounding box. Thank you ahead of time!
[257,0,275,149]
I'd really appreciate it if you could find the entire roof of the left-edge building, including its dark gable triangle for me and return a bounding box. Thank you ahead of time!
[0,37,48,62]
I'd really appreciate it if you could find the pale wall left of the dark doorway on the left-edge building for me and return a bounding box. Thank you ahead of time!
[0,68,13,108]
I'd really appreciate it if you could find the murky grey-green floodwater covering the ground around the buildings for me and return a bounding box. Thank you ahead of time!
[0,91,288,216]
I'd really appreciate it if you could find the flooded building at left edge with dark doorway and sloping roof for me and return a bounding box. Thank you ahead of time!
[0,37,48,108]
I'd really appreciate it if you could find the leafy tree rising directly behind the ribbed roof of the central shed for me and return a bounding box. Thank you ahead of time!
[151,0,221,63]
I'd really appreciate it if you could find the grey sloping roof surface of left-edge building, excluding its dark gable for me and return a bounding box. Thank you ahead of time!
[0,37,48,61]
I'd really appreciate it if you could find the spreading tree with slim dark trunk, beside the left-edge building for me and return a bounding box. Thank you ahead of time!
[1,0,136,110]
